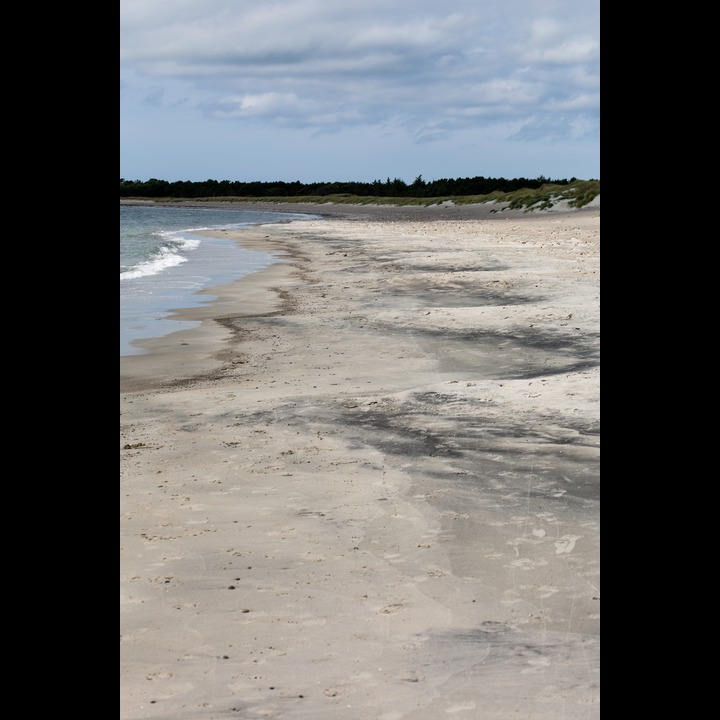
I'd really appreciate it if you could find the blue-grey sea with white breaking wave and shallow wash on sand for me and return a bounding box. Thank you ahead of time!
[120,205,318,355]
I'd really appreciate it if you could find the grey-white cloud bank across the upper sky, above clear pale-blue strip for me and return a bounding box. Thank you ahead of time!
[120,0,599,180]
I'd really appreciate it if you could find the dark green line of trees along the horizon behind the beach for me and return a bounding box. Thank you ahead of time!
[120,175,577,198]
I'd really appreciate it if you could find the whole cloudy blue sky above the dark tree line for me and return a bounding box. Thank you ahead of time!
[119,0,600,183]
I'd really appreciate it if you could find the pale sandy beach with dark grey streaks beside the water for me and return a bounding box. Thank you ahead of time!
[120,203,600,720]
